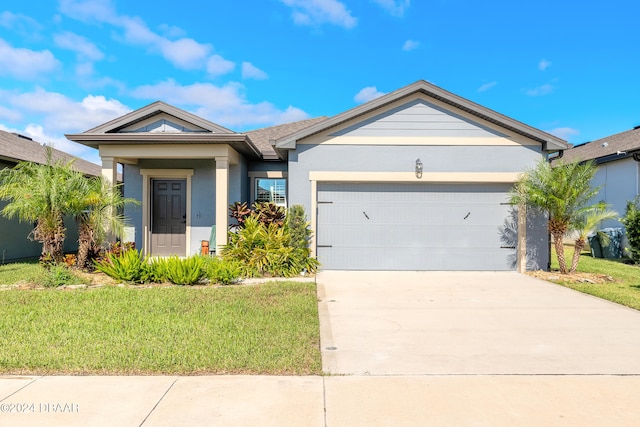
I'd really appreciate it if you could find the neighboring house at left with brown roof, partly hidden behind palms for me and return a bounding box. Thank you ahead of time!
[0,130,101,263]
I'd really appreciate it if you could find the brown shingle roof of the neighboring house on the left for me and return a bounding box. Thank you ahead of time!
[0,130,102,176]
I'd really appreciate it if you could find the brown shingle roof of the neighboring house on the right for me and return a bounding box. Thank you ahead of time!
[562,126,640,162]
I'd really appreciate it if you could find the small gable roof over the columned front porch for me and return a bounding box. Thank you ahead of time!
[65,101,261,158]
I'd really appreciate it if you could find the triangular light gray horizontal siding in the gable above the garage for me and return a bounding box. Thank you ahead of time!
[332,99,504,138]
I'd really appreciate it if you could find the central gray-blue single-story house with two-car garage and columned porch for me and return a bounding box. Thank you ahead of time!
[67,81,567,270]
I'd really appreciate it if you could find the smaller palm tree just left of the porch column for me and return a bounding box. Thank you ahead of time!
[73,177,137,268]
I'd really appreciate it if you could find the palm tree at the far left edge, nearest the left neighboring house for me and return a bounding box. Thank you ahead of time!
[0,147,77,262]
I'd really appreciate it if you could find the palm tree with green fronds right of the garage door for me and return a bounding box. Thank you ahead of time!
[510,159,598,274]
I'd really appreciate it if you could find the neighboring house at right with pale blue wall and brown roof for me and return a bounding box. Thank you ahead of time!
[554,126,640,227]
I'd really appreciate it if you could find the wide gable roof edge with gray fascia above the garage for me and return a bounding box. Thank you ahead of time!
[276,80,568,151]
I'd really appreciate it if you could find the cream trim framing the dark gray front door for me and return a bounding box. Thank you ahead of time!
[140,169,193,256]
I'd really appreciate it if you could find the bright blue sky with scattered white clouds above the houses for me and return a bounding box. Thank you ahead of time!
[0,0,640,162]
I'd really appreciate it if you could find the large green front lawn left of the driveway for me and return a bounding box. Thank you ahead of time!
[0,280,321,375]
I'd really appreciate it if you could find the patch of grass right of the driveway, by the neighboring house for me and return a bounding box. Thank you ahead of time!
[551,246,640,310]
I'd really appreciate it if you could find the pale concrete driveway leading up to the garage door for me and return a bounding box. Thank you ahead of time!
[317,271,640,375]
